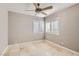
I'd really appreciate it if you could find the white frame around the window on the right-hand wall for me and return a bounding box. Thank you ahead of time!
[45,17,60,35]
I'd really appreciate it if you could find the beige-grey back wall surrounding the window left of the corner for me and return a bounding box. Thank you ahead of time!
[8,12,44,44]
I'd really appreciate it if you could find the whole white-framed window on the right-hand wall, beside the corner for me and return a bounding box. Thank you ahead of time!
[46,18,59,34]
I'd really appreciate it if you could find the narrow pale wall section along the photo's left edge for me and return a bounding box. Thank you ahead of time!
[0,7,8,55]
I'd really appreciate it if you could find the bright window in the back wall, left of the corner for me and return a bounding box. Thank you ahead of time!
[33,20,44,33]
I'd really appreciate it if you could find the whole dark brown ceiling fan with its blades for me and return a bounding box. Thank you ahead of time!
[25,3,53,15]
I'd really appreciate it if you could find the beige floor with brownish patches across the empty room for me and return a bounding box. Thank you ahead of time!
[4,40,79,56]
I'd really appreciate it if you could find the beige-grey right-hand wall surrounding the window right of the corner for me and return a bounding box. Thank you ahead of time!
[45,4,79,51]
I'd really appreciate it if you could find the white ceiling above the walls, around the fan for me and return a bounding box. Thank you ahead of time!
[0,3,74,17]
